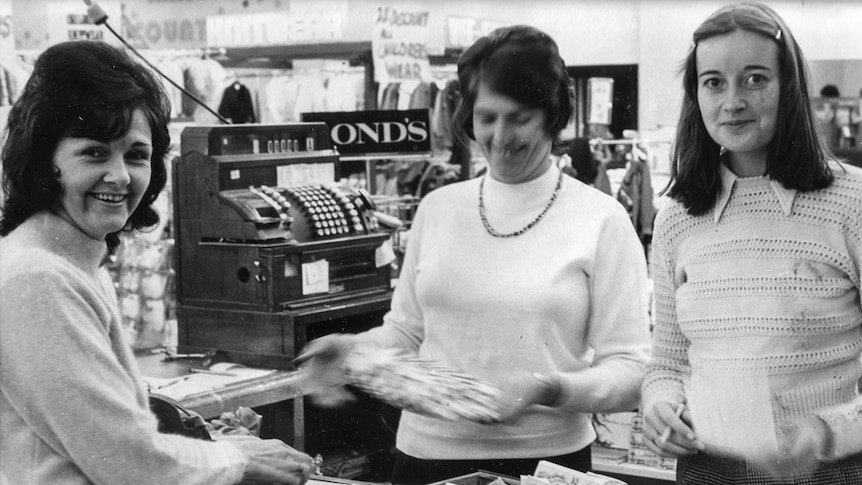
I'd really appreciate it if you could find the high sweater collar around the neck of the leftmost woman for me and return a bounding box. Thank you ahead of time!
[23,211,108,271]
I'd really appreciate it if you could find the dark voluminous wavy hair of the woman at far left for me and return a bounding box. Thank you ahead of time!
[0,41,171,252]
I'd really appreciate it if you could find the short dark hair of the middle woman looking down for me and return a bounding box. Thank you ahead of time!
[453,25,575,155]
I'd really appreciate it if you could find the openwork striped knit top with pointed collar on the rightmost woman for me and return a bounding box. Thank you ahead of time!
[643,165,862,461]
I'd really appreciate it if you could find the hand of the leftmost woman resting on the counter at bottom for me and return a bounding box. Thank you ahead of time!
[219,435,314,485]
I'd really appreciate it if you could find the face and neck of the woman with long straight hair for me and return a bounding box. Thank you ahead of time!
[697,30,780,176]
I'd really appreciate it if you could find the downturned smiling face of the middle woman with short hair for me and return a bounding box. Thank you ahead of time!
[473,82,553,184]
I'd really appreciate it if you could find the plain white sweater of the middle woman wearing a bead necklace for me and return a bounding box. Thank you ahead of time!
[356,167,649,459]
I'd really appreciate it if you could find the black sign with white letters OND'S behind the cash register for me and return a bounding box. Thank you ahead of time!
[302,109,431,155]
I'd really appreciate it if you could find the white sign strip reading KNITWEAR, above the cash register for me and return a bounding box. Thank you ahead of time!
[206,11,344,47]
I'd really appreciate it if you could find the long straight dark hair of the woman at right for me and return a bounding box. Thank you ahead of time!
[664,3,834,215]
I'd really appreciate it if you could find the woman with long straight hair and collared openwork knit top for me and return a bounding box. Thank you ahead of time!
[643,4,862,485]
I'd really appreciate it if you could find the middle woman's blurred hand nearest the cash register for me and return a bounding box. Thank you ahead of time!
[295,334,356,407]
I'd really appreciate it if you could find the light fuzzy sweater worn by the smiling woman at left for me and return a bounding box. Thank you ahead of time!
[0,212,246,485]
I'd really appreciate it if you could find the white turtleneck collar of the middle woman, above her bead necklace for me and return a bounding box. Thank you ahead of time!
[484,164,560,213]
